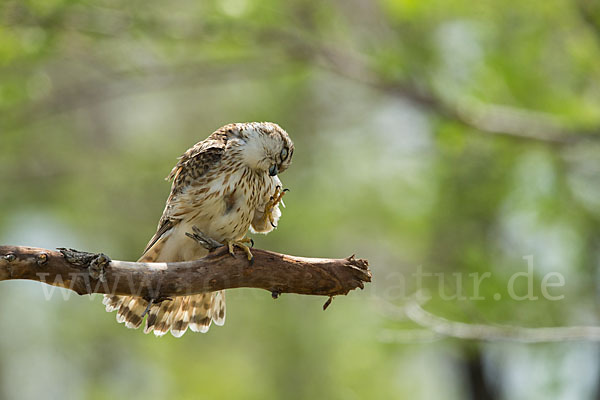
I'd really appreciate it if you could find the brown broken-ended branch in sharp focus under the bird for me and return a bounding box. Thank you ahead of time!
[0,246,371,299]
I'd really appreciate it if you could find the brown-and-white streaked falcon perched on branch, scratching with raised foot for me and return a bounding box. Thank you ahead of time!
[103,122,294,337]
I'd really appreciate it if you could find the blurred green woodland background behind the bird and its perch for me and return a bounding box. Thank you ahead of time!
[0,0,600,399]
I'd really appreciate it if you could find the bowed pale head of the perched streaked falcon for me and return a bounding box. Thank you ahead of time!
[233,122,294,176]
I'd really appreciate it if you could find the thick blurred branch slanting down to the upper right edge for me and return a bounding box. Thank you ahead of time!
[272,31,600,145]
